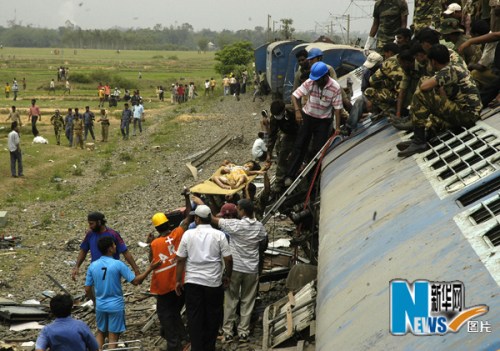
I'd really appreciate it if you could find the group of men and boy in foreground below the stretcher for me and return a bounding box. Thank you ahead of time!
[36,184,267,351]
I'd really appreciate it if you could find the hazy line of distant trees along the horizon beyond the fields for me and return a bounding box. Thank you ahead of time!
[0,21,332,51]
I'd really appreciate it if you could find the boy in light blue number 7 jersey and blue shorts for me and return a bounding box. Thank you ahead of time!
[85,236,162,349]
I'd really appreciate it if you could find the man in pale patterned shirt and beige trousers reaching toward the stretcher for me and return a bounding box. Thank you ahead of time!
[212,199,267,343]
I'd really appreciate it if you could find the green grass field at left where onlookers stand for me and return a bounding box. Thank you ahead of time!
[0,48,225,209]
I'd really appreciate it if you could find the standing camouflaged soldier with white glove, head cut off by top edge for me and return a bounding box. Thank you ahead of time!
[364,0,408,54]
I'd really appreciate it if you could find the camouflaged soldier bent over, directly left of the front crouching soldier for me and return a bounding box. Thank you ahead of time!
[365,46,404,113]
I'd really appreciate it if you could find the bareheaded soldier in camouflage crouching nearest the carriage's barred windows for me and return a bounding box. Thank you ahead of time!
[397,44,482,157]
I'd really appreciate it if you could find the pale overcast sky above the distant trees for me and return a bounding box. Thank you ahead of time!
[0,0,413,34]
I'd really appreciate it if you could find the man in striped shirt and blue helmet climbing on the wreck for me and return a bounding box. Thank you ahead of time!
[285,61,343,186]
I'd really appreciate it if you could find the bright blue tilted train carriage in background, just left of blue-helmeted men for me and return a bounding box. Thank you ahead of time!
[266,40,303,98]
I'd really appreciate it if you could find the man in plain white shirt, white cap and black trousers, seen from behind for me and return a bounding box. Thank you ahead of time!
[175,205,233,351]
